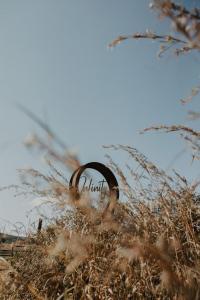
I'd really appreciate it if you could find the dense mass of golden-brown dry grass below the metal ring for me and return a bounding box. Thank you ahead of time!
[0,180,200,300]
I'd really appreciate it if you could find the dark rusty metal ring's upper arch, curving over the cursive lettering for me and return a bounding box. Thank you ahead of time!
[69,162,119,200]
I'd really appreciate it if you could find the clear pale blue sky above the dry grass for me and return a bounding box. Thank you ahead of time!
[0,0,200,232]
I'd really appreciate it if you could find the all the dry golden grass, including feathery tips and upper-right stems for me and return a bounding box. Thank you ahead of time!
[0,1,200,300]
